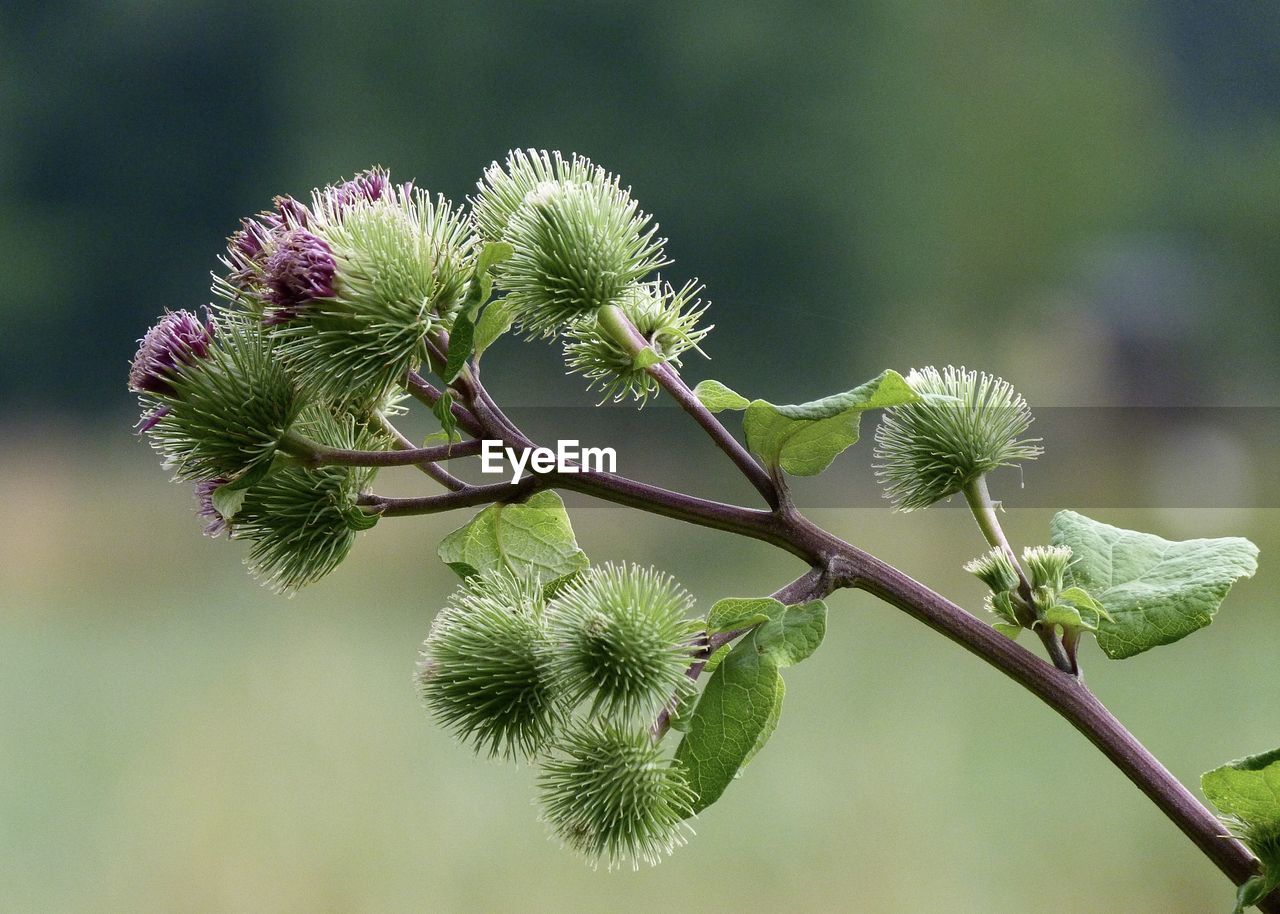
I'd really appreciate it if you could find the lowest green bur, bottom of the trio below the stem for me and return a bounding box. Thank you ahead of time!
[538,721,694,869]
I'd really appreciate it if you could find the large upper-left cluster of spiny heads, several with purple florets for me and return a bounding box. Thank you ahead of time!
[129,156,707,590]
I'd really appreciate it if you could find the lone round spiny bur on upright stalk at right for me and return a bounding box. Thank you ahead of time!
[876,365,1043,511]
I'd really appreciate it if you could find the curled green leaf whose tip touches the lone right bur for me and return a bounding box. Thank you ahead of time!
[742,371,920,476]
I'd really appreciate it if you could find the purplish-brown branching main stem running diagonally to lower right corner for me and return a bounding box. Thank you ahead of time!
[376,340,1280,914]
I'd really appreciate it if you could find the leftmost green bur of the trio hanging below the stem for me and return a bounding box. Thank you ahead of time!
[417,573,562,758]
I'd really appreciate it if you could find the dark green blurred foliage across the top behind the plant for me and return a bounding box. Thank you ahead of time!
[0,0,1280,410]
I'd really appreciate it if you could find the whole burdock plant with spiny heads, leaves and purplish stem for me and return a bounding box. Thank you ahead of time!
[129,150,1280,914]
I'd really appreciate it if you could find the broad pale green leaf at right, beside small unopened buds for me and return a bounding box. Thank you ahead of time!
[1051,511,1258,659]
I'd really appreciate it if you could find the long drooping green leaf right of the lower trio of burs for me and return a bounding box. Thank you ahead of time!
[676,600,827,812]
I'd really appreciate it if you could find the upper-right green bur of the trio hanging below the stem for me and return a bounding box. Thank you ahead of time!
[548,565,695,718]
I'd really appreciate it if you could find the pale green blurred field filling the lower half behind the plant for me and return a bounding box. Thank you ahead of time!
[0,422,1280,914]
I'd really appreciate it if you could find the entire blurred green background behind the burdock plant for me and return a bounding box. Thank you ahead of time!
[0,0,1280,913]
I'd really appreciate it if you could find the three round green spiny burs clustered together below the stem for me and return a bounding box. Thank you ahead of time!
[417,565,698,867]
